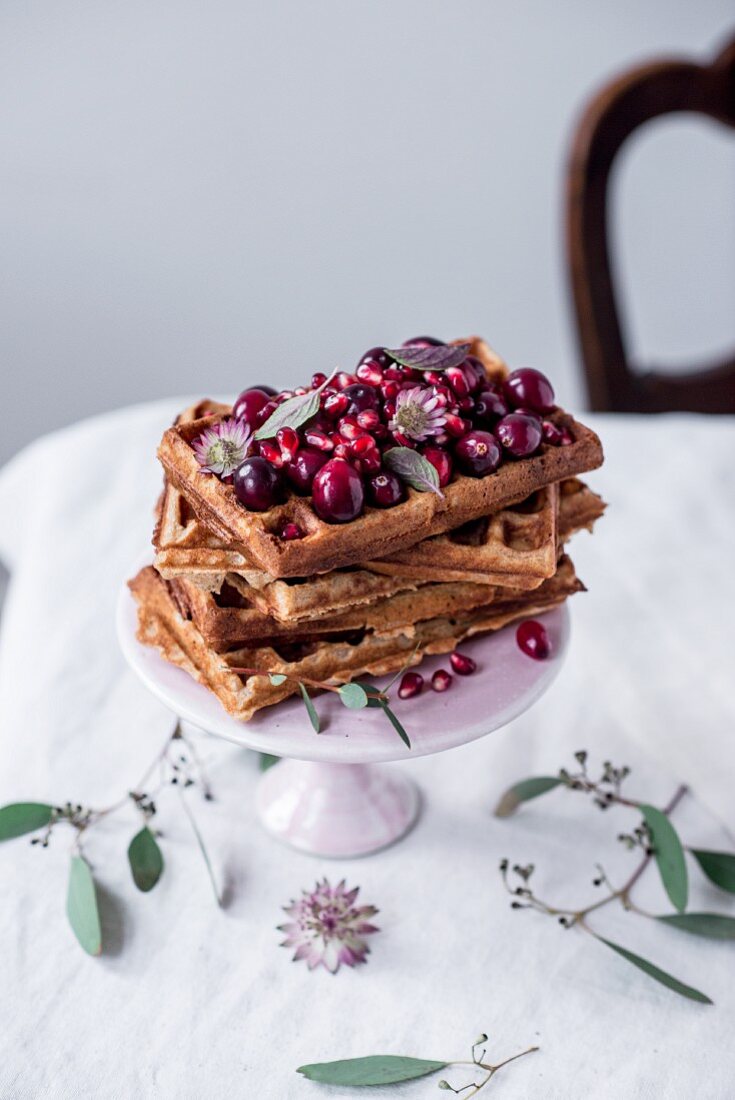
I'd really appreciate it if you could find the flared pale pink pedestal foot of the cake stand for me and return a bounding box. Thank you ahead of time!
[256,760,420,859]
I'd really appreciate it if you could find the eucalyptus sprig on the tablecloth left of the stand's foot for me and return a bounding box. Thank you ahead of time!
[0,722,220,955]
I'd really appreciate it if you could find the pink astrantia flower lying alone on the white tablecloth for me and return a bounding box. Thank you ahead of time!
[278,879,379,974]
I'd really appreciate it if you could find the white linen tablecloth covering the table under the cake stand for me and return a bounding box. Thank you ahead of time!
[0,399,735,1100]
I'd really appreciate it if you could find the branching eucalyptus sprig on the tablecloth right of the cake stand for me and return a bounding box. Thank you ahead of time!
[495,751,735,1004]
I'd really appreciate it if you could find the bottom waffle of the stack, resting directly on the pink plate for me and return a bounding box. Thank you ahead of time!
[129,558,582,722]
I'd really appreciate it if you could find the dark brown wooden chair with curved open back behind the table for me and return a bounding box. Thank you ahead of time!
[567,39,735,413]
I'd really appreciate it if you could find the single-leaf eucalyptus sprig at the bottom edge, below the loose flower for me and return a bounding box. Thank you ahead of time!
[296,1034,539,1097]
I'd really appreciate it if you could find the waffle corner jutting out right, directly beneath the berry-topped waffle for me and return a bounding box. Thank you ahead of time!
[368,477,605,589]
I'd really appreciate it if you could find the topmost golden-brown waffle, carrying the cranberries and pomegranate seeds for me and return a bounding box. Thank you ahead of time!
[158,339,602,578]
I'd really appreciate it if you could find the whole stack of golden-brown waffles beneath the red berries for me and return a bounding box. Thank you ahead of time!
[130,341,604,721]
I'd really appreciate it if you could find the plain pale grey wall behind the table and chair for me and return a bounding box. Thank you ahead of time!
[0,0,735,461]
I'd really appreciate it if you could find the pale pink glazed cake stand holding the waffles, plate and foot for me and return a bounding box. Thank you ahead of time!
[118,586,569,858]
